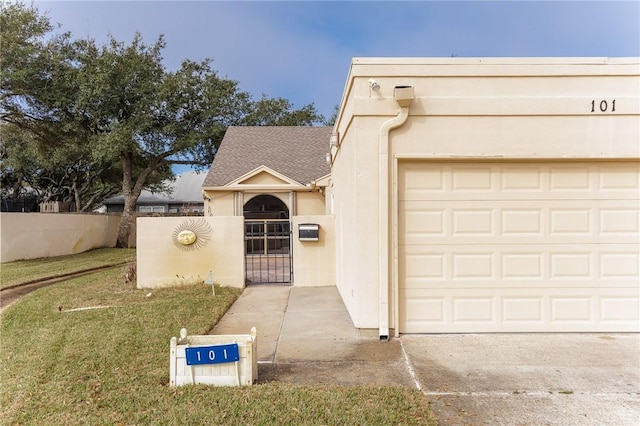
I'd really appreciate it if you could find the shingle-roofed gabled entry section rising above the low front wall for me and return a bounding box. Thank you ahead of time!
[202,126,331,219]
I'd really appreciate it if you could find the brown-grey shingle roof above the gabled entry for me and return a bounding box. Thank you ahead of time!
[202,126,332,187]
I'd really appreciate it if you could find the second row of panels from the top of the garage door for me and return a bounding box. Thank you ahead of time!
[399,200,640,244]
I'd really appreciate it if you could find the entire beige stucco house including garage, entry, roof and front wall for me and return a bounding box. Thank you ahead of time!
[138,58,640,339]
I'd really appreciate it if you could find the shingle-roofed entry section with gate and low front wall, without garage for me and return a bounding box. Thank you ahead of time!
[137,126,335,287]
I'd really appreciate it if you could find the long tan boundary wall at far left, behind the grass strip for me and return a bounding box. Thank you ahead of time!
[0,213,120,263]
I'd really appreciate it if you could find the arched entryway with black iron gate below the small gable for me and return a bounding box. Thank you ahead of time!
[243,194,293,284]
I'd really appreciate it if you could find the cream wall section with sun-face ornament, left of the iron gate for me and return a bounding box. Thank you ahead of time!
[137,216,244,288]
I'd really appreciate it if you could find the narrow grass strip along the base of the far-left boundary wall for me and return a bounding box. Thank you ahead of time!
[0,248,136,288]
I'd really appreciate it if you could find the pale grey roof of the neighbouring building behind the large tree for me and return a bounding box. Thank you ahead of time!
[104,172,205,204]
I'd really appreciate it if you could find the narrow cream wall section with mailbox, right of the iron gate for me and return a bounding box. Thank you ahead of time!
[291,216,336,287]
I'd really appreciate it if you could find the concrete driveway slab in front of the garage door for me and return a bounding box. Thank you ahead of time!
[401,334,640,425]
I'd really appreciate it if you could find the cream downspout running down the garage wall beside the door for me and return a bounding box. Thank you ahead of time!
[378,99,410,340]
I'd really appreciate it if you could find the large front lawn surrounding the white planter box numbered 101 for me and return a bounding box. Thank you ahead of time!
[0,255,435,425]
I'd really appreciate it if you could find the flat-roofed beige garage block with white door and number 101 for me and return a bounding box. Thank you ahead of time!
[329,58,640,337]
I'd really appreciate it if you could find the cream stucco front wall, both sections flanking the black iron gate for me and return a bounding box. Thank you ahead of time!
[137,216,335,288]
